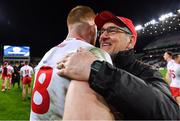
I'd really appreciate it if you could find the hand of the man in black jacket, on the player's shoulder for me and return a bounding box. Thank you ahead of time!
[57,49,97,81]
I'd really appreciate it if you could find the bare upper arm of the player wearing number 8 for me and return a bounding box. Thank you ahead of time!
[63,49,114,120]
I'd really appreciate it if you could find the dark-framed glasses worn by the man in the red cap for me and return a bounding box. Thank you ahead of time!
[98,26,131,36]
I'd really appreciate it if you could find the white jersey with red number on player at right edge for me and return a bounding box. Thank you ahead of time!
[170,62,180,88]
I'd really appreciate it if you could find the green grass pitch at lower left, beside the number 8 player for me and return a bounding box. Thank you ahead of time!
[0,77,31,120]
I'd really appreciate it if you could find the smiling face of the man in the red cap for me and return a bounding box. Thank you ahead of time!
[99,22,132,54]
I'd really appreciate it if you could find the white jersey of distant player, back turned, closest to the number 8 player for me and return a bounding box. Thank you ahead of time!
[20,65,34,77]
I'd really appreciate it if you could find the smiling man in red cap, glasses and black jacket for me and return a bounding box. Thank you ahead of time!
[58,11,180,119]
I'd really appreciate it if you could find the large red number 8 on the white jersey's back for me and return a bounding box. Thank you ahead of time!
[32,66,53,114]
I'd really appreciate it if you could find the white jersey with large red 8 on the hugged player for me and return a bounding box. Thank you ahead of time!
[30,38,112,120]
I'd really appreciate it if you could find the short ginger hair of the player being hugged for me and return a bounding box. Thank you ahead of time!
[67,5,95,25]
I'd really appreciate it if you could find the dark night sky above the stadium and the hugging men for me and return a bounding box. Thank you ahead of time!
[0,0,180,57]
